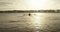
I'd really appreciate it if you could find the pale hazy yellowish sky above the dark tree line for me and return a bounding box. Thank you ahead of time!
[0,0,60,10]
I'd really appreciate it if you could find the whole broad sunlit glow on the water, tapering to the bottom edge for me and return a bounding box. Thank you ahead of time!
[31,13,46,32]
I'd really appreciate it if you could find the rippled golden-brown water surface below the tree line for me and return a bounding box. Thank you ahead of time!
[0,13,60,32]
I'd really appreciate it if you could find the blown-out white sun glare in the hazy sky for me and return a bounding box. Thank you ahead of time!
[32,0,48,9]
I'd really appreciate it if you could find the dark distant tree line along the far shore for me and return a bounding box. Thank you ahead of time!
[0,10,60,13]
